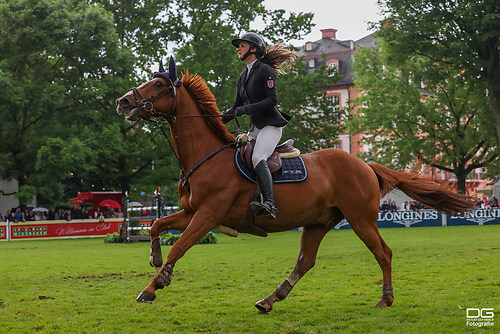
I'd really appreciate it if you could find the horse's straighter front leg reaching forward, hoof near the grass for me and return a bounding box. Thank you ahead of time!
[137,209,220,302]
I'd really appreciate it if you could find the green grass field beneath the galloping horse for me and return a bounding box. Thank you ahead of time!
[0,225,500,333]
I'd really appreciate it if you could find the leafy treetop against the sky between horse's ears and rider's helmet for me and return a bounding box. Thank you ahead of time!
[165,0,312,111]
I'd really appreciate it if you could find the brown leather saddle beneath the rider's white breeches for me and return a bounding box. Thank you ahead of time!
[237,134,300,174]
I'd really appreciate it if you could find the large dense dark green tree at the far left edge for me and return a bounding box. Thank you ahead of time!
[0,0,132,204]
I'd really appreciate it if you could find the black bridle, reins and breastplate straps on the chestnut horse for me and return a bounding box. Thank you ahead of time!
[132,79,246,193]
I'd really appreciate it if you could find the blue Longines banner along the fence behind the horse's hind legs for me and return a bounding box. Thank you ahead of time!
[335,208,500,230]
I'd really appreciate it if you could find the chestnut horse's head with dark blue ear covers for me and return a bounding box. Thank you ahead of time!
[116,57,182,121]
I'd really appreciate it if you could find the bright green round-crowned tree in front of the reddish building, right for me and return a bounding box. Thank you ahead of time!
[347,45,499,192]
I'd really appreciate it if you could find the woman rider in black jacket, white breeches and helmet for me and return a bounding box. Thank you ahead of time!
[222,32,295,219]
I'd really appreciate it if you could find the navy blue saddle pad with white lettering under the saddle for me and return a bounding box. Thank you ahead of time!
[234,150,307,183]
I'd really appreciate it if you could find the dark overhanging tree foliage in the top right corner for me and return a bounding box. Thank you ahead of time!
[379,0,500,143]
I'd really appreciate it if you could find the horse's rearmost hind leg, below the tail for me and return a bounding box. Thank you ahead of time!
[348,219,394,307]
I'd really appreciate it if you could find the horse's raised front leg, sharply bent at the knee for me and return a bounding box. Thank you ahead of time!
[149,210,193,272]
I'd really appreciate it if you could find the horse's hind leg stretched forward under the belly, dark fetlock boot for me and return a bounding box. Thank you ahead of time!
[255,224,335,312]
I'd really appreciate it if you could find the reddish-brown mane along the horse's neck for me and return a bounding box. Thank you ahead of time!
[181,70,236,144]
